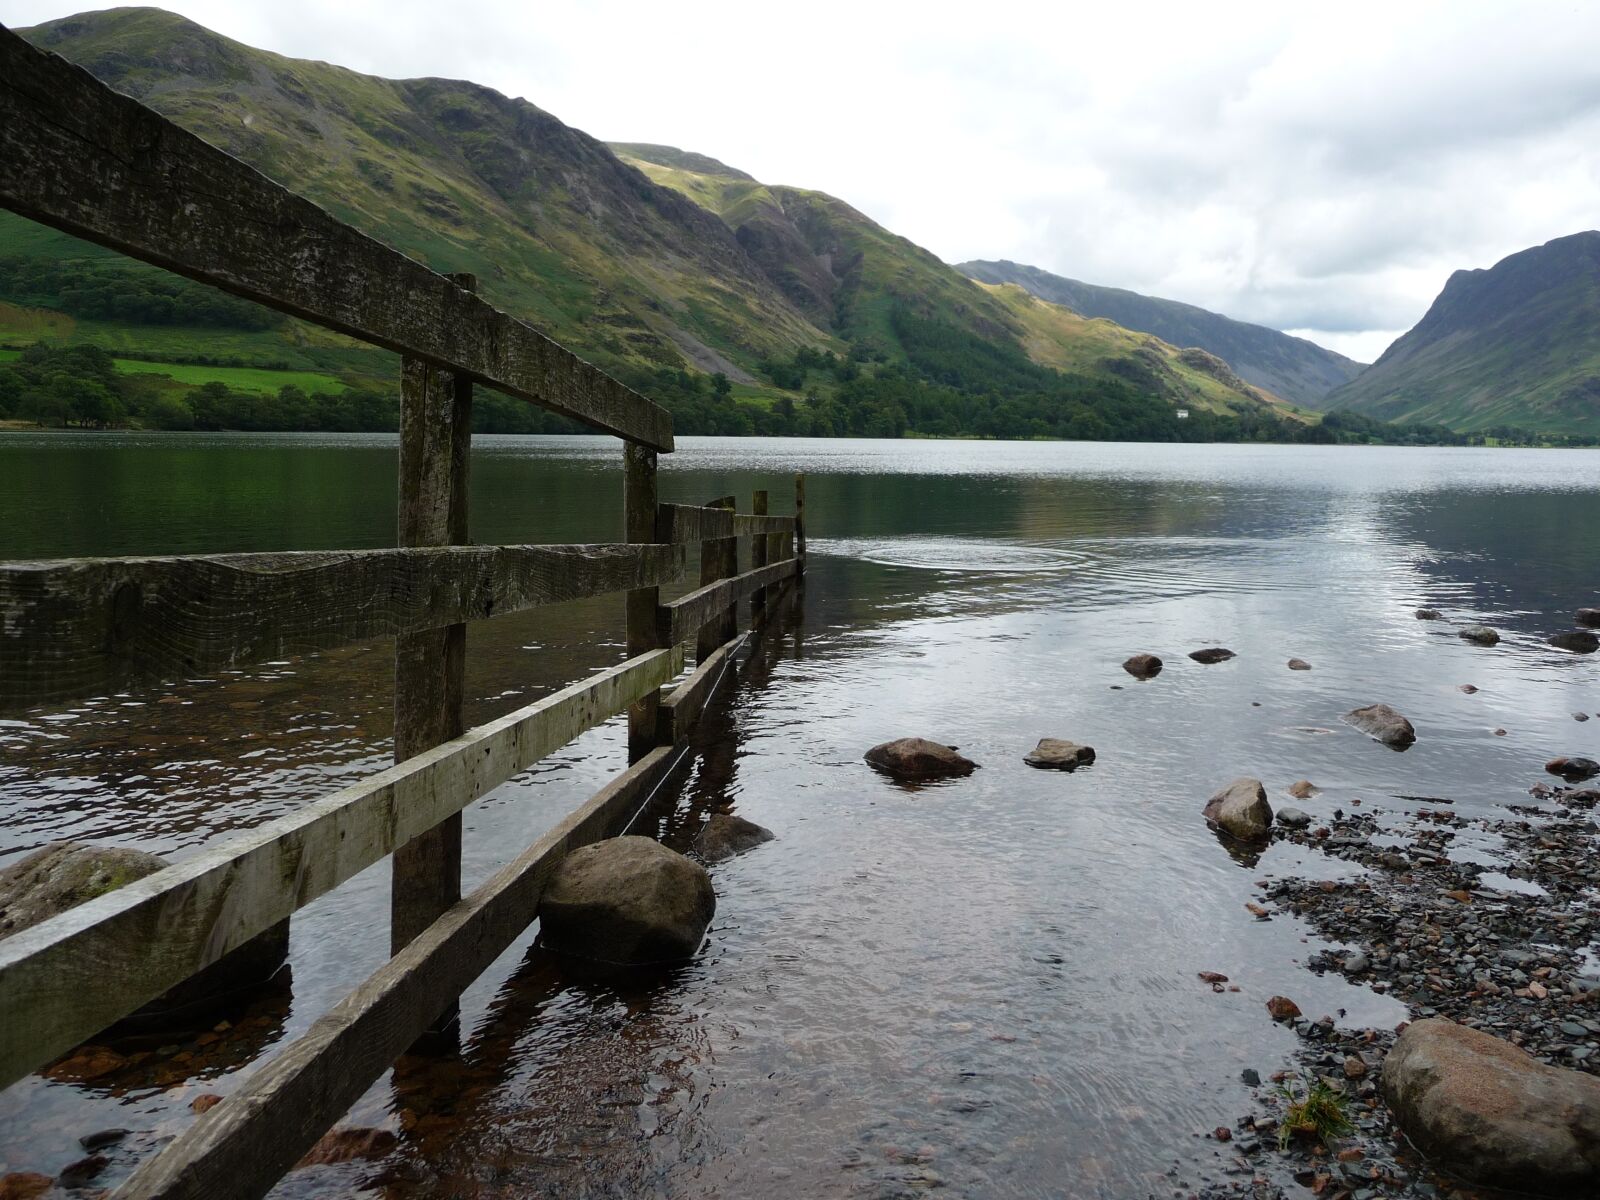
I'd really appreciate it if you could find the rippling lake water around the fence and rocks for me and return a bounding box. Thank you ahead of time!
[0,435,1600,1197]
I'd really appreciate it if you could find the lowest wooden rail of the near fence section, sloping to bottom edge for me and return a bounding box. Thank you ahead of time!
[114,746,675,1200]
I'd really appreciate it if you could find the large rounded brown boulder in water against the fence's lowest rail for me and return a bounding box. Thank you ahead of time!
[539,837,717,966]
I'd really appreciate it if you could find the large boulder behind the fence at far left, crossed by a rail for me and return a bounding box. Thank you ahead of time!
[0,842,290,1027]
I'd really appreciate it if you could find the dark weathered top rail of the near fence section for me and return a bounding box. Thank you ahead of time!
[0,27,672,450]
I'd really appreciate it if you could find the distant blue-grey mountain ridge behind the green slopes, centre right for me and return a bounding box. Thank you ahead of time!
[957,259,1362,408]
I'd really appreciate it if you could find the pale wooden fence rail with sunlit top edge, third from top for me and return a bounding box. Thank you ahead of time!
[0,648,683,1088]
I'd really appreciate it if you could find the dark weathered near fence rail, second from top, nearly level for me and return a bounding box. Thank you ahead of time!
[0,546,686,710]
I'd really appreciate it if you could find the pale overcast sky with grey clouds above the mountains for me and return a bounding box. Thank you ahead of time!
[0,0,1600,360]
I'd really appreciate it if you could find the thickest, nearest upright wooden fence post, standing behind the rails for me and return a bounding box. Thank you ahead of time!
[389,275,477,960]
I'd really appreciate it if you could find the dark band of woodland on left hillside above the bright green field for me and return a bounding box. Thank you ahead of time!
[0,258,285,330]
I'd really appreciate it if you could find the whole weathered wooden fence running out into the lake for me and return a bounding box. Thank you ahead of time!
[0,27,805,1200]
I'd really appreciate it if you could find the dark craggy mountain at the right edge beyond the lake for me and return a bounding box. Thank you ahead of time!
[1328,230,1600,435]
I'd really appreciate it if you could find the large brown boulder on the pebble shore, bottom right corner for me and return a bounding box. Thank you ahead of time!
[1382,1018,1600,1197]
